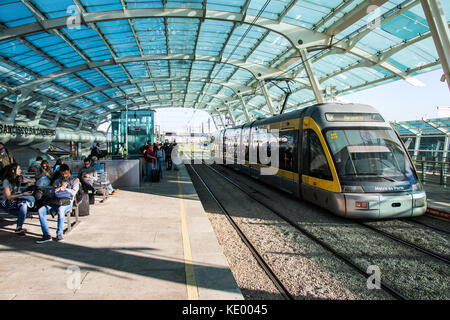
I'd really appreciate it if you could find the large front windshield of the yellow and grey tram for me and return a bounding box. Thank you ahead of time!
[326,128,417,183]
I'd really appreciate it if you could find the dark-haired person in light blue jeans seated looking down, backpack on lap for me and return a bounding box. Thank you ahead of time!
[36,164,80,243]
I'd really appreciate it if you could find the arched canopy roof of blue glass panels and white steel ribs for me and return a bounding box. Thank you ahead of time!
[0,0,450,129]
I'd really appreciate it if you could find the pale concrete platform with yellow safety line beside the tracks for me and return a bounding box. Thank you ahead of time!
[0,166,243,300]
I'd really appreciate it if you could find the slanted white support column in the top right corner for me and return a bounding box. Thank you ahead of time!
[420,0,450,90]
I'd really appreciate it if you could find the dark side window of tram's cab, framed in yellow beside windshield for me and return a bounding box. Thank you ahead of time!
[303,129,333,180]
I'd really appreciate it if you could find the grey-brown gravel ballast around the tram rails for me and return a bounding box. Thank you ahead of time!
[191,166,449,299]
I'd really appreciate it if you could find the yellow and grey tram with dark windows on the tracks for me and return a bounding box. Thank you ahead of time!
[213,103,426,219]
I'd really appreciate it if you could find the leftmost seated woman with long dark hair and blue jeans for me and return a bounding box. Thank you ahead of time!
[3,163,34,235]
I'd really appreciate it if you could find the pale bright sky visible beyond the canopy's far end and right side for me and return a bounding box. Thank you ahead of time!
[155,69,450,132]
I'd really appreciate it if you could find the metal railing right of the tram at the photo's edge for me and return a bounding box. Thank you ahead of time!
[414,160,450,187]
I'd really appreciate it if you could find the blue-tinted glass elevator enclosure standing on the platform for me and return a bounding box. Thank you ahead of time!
[111,110,155,156]
